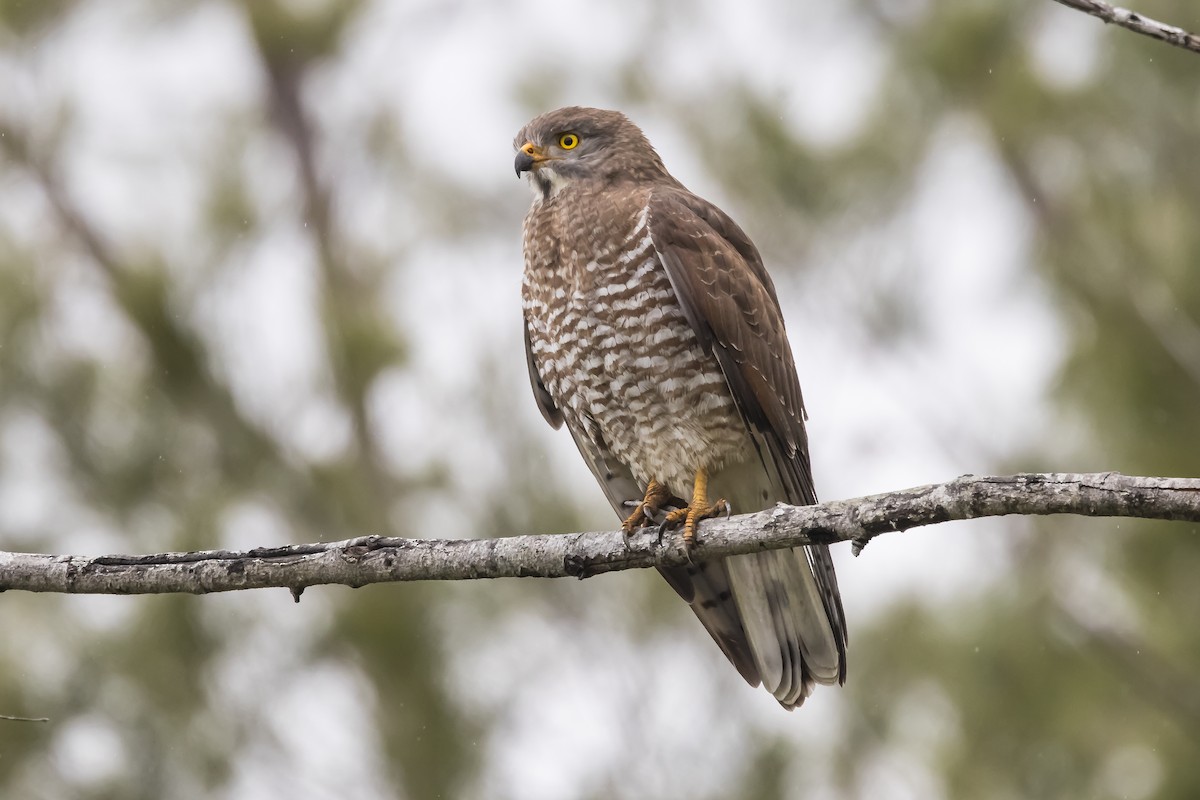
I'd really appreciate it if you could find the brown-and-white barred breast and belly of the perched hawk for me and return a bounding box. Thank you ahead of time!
[522,193,749,497]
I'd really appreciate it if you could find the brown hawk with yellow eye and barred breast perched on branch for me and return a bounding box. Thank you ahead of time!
[514,107,846,709]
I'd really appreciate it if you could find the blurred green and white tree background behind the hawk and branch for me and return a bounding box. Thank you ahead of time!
[0,0,1200,800]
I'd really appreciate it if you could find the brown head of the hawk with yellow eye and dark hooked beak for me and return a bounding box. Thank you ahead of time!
[512,106,670,199]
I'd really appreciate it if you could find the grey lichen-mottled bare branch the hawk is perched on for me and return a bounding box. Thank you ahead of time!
[0,473,1200,600]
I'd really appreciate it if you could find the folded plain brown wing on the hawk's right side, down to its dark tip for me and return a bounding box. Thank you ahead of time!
[649,187,846,681]
